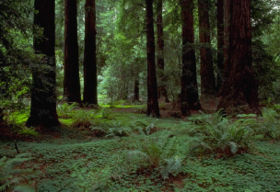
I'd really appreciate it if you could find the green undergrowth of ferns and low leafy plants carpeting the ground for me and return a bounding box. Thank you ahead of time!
[0,105,280,192]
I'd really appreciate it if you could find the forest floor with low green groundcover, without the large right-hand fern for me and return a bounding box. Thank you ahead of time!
[0,105,280,192]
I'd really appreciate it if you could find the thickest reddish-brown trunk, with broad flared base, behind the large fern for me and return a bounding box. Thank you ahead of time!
[219,0,259,112]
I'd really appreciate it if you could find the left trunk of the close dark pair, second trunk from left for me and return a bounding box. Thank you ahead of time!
[64,0,81,103]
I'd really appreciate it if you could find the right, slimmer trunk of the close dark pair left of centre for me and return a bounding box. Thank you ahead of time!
[84,0,97,105]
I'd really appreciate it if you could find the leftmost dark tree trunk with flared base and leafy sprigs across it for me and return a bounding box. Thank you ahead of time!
[27,0,59,128]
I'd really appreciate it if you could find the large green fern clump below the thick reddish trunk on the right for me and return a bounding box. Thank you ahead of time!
[189,112,256,155]
